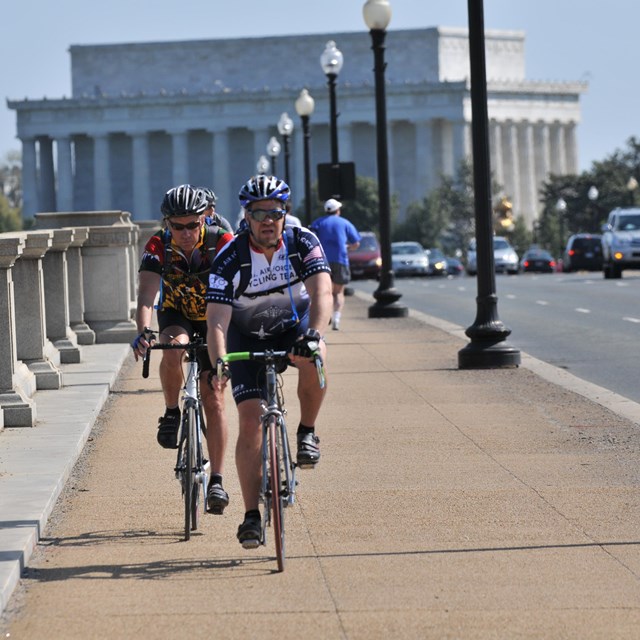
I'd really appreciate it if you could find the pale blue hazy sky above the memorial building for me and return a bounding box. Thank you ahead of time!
[0,0,640,170]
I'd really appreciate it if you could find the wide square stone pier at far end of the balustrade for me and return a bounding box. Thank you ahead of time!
[82,225,137,343]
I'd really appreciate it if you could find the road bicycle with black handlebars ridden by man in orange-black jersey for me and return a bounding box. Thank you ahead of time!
[142,335,209,540]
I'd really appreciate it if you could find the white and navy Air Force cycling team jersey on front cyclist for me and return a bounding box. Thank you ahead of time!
[206,228,331,340]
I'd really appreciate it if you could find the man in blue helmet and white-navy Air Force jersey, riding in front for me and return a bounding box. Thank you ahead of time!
[207,175,333,548]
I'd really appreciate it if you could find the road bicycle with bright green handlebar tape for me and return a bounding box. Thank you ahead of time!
[217,342,325,571]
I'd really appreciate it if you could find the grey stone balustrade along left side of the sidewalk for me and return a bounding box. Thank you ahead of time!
[0,211,145,431]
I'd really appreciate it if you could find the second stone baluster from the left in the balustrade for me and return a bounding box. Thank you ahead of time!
[13,231,62,389]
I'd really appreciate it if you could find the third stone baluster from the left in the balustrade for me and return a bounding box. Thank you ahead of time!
[42,229,80,364]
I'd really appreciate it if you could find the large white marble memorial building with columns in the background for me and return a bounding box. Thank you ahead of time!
[8,28,586,224]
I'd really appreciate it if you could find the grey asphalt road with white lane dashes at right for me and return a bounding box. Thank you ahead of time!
[351,271,640,402]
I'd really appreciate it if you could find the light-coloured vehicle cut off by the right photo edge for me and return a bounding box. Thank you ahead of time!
[602,208,640,279]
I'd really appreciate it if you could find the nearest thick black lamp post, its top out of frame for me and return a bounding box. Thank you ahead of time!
[458,0,520,369]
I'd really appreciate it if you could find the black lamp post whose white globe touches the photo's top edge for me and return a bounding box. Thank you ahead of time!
[362,0,409,318]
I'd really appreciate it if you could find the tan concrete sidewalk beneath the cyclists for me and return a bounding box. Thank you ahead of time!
[0,297,640,639]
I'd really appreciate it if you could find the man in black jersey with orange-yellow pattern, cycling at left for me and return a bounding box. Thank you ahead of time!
[132,185,233,513]
